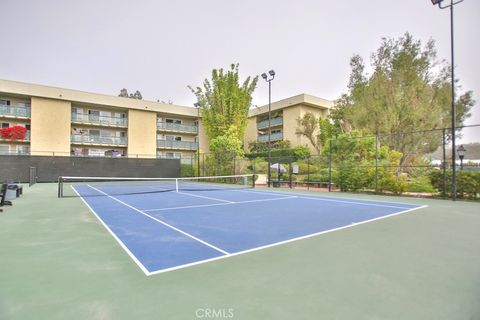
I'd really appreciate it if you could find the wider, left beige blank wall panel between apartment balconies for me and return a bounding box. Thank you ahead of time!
[30,97,71,156]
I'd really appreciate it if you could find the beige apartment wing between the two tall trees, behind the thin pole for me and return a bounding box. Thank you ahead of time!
[244,94,333,152]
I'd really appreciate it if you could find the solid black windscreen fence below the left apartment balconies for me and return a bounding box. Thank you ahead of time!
[0,155,181,183]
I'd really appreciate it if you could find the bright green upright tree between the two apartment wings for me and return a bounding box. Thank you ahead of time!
[188,64,258,158]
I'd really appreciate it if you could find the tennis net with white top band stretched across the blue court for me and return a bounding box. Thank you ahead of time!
[58,174,255,198]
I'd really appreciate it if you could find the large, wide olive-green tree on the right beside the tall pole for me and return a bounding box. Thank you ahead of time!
[331,33,474,164]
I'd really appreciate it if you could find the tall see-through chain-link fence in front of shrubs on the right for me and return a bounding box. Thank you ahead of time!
[181,125,480,199]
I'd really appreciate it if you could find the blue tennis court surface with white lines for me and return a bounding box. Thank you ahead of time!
[74,185,421,275]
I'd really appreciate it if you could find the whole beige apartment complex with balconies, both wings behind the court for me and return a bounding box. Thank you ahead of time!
[0,80,333,161]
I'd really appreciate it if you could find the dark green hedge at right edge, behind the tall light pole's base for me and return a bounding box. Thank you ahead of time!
[430,170,480,199]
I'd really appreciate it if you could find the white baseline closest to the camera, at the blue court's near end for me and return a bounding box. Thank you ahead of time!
[148,206,428,276]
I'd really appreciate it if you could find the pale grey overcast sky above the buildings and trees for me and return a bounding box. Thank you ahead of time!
[0,0,480,141]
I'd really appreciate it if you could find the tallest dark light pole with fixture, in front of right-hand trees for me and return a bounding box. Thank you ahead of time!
[431,0,463,201]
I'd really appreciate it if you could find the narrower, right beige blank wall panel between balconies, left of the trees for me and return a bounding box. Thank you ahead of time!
[127,109,157,158]
